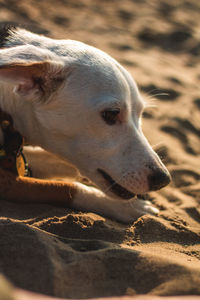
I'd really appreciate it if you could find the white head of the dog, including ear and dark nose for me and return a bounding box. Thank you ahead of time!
[0,29,170,199]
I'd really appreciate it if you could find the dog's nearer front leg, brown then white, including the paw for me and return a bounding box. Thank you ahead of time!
[0,169,158,223]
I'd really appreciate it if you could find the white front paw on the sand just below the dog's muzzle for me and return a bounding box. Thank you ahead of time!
[117,199,159,223]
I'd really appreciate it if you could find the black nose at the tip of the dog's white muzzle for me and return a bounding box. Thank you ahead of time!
[148,169,171,191]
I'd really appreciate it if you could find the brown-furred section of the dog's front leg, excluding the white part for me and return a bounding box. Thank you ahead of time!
[0,169,76,206]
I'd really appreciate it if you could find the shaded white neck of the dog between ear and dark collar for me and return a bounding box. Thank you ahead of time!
[0,83,41,146]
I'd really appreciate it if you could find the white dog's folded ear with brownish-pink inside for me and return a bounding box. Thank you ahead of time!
[0,45,64,99]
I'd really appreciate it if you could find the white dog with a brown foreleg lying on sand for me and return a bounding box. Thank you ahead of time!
[0,27,170,223]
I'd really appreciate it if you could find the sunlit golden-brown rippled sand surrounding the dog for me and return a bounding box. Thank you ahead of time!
[0,0,200,300]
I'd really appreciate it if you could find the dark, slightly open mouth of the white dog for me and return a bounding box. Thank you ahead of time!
[97,169,135,200]
